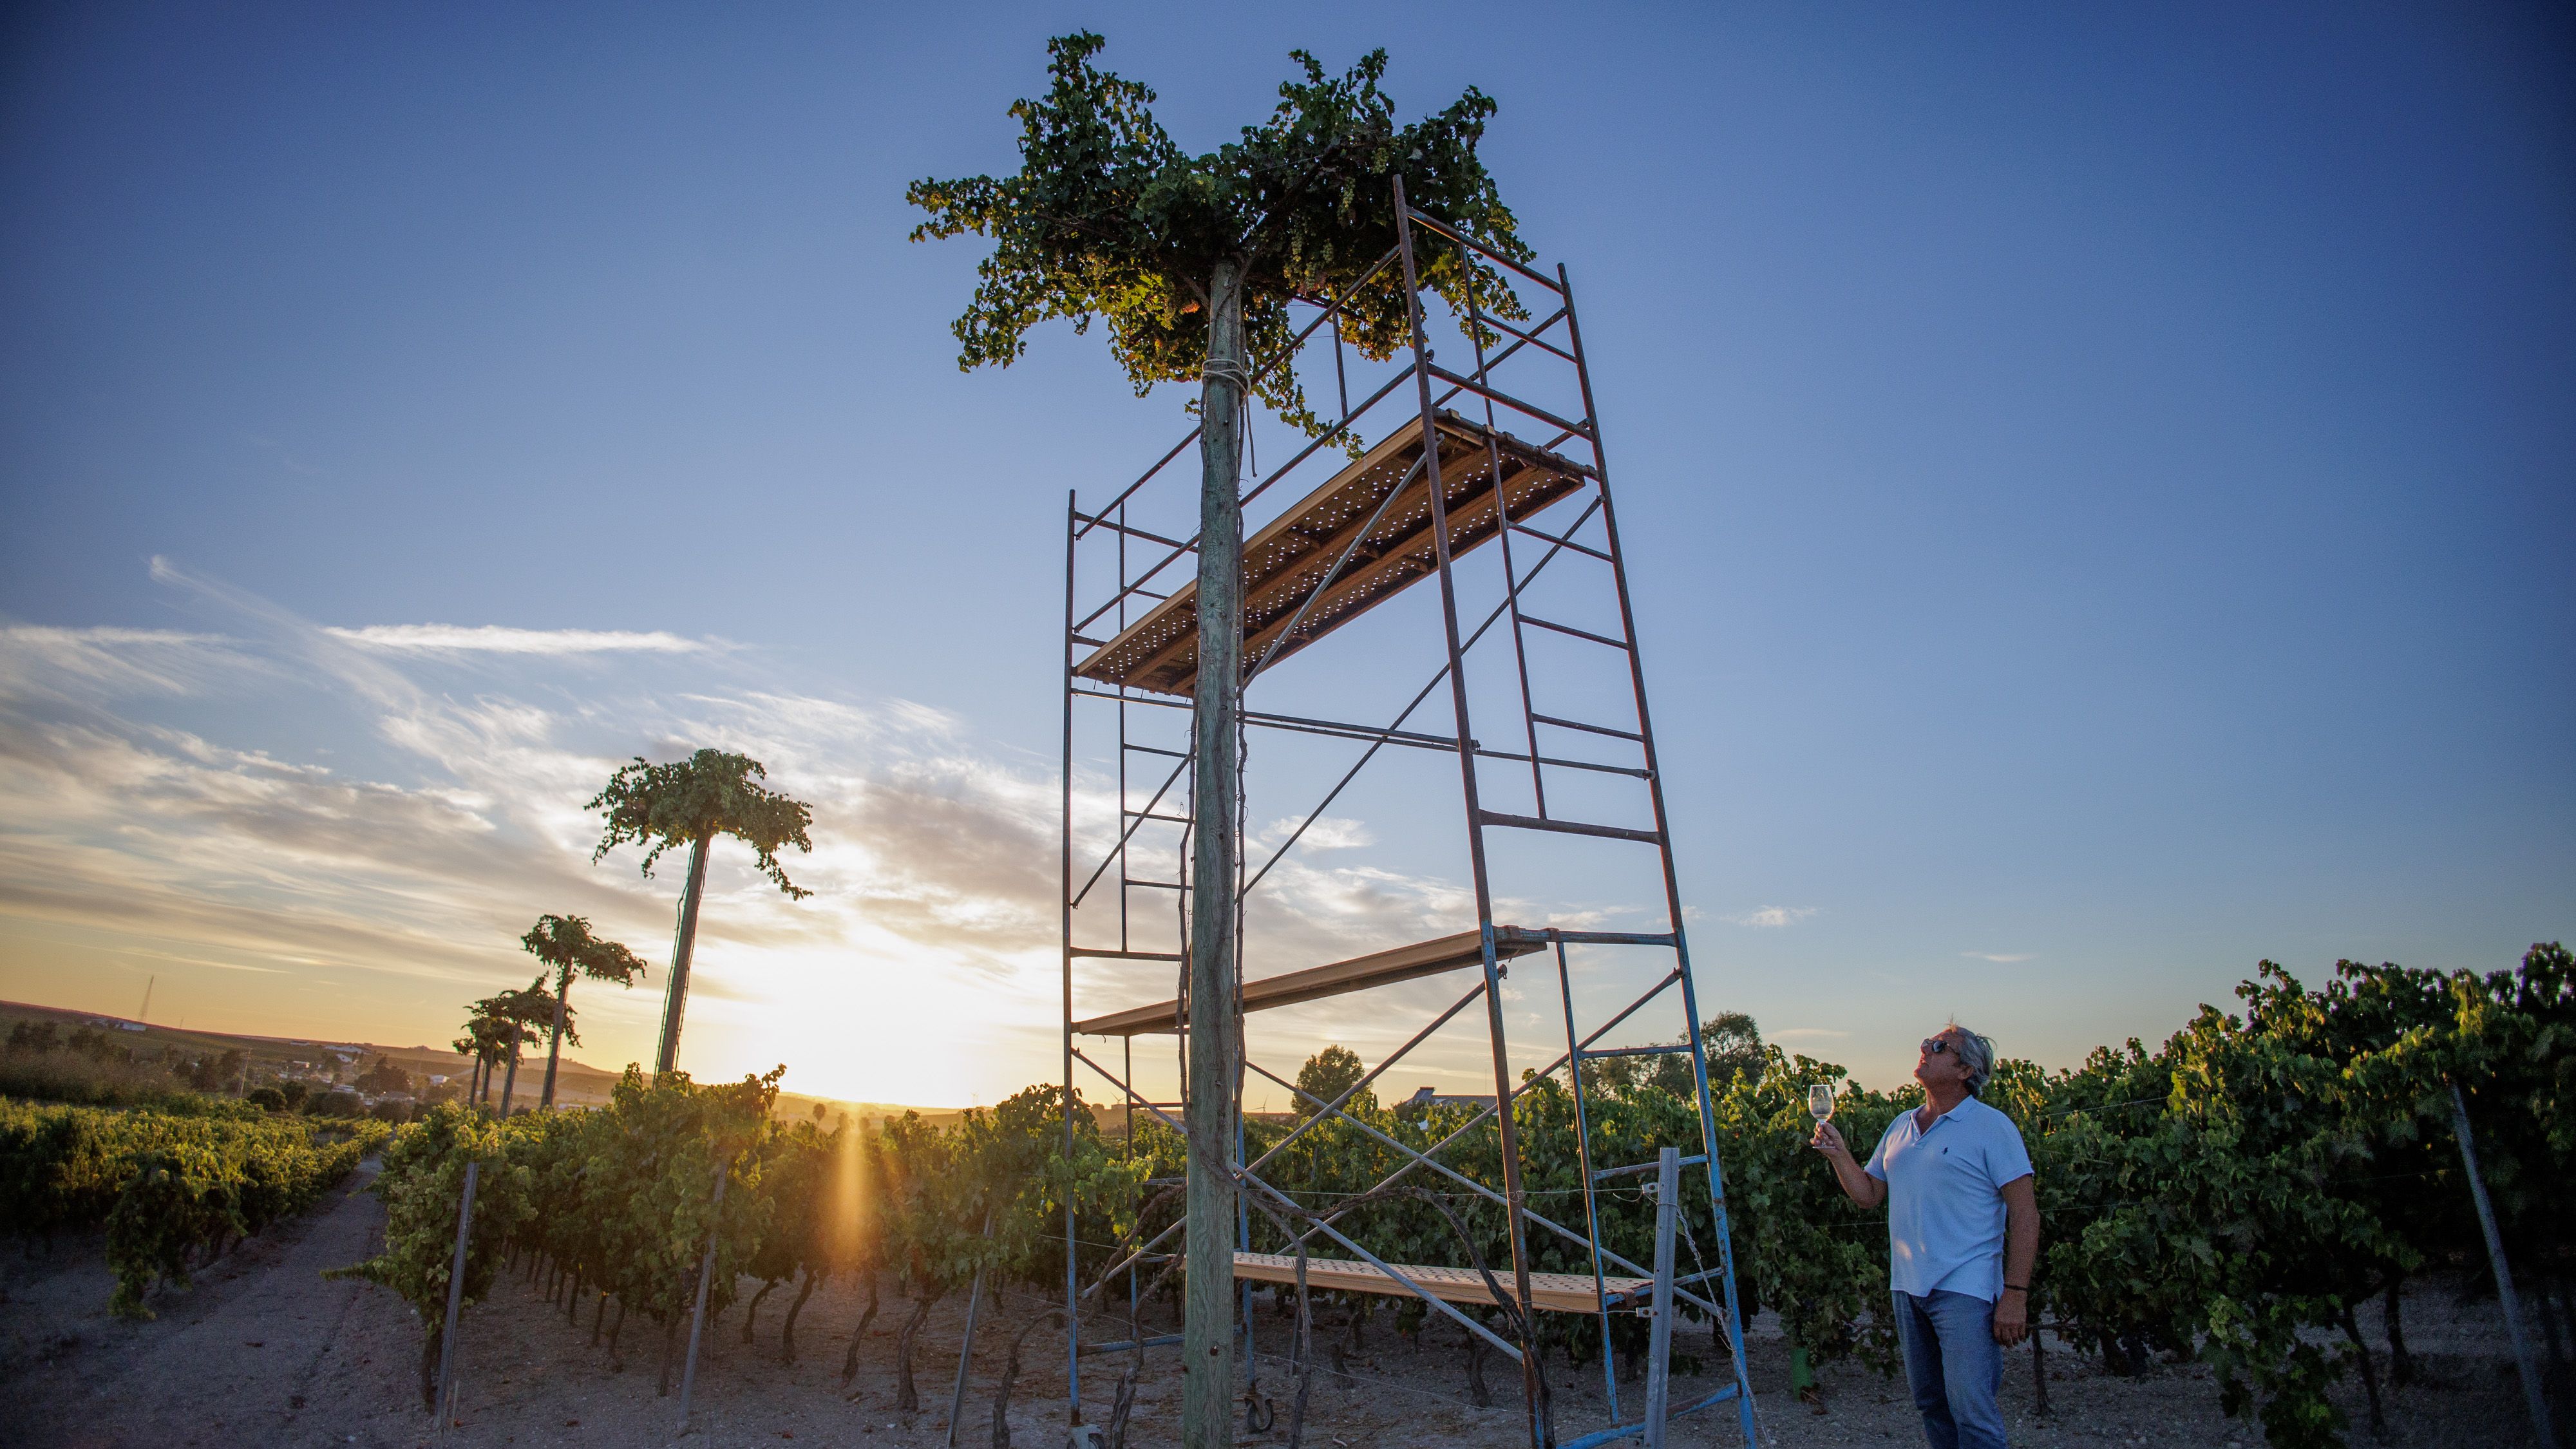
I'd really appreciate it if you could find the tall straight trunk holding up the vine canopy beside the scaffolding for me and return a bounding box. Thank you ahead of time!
[1180,260,1247,1449]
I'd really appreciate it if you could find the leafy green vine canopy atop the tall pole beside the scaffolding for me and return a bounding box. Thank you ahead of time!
[904,31,1530,433]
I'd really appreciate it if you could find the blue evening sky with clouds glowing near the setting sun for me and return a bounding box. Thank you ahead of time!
[0,5,2576,1106]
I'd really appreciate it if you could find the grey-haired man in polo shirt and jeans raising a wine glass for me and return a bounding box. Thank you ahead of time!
[1811,1023,2040,1449]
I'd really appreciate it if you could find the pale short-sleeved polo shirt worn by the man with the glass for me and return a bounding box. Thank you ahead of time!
[1868,1096,2030,1302]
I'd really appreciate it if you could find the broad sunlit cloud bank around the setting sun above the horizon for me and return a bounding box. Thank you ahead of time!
[0,560,1638,1101]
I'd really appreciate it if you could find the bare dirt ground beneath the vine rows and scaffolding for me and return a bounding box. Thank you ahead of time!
[0,1173,2532,1449]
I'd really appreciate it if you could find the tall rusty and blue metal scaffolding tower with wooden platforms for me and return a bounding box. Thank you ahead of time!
[1061,200,1754,1449]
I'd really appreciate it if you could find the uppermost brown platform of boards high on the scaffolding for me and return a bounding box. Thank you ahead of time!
[1074,410,1584,694]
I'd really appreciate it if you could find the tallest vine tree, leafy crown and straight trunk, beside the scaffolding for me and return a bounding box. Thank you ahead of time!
[907,33,1530,1449]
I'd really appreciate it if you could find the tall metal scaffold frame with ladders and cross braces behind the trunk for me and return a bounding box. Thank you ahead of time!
[1061,185,1754,1449]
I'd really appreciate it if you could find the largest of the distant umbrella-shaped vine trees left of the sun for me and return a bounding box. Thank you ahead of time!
[585,750,814,1072]
